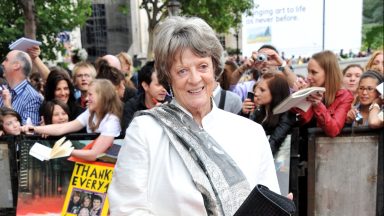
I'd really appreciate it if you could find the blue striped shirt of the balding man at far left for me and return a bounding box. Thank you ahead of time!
[0,80,42,125]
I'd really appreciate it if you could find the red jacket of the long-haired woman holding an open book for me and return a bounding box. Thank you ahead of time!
[294,89,354,137]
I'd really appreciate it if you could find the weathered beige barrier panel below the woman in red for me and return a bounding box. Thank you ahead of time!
[306,128,384,216]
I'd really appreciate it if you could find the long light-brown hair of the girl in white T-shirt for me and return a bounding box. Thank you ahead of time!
[88,79,123,132]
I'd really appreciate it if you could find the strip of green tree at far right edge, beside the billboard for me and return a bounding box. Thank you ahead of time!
[362,0,384,50]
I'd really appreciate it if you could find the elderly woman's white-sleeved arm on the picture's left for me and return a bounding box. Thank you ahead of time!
[108,119,155,215]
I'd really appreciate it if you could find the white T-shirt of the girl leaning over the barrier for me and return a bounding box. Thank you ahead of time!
[76,109,121,137]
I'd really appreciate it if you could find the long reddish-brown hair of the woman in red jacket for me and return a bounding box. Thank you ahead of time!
[312,50,343,107]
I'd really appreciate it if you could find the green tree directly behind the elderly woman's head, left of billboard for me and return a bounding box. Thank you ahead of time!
[140,0,253,59]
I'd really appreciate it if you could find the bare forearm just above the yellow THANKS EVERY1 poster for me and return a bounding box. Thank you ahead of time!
[71,135,115,161]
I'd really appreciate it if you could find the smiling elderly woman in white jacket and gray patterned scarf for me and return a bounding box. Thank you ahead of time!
[108,17,279,215]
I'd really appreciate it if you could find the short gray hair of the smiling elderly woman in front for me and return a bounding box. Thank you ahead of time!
[154,16,224,86]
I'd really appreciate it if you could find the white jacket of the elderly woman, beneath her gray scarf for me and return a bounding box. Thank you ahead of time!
[108,103,280,216]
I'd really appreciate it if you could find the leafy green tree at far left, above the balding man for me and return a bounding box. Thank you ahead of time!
[0,0,92,60]
